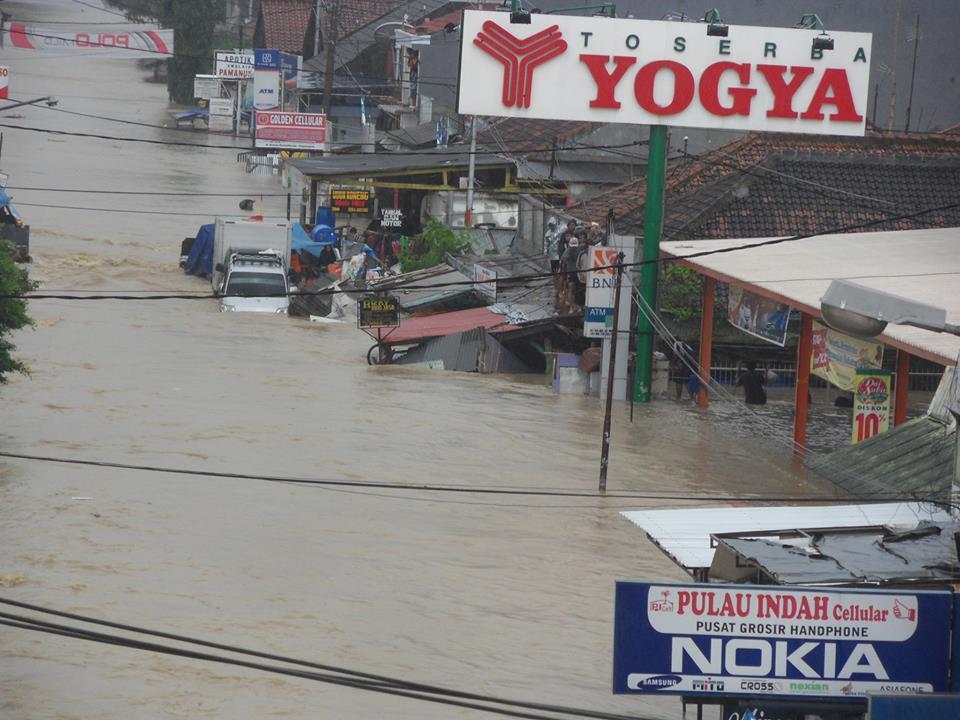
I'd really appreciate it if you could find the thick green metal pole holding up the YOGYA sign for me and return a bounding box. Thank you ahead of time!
[633,125,667,403]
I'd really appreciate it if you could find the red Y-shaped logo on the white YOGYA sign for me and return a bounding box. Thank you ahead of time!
[473,20,567,107]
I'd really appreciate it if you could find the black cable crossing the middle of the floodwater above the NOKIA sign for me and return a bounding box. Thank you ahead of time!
[0,452,927,504]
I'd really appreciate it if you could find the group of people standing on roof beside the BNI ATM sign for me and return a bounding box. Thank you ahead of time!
[543,217,604,313]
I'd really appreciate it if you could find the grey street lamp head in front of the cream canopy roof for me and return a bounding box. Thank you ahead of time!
[820,280,960,337]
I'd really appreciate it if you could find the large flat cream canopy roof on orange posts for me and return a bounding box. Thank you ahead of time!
[661,228,960,365]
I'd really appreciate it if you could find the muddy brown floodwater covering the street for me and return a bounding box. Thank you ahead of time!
[0,0,832,720]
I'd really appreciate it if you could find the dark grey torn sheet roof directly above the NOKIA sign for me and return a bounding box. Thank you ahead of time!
[710,522,960,585]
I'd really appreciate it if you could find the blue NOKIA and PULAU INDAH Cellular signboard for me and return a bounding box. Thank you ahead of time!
[613,582,953,701]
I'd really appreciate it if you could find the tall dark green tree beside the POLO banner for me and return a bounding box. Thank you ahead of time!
[107,0,225,105]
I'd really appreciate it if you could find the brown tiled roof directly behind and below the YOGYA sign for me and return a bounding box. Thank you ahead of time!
[571,134,960,240]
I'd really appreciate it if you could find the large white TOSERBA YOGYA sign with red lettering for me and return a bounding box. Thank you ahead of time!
[458,10,872,135]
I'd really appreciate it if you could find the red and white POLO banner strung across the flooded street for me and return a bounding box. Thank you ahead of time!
[2,23,173,60]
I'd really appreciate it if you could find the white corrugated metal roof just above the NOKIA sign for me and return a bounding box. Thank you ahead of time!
[621,503,950,572]
